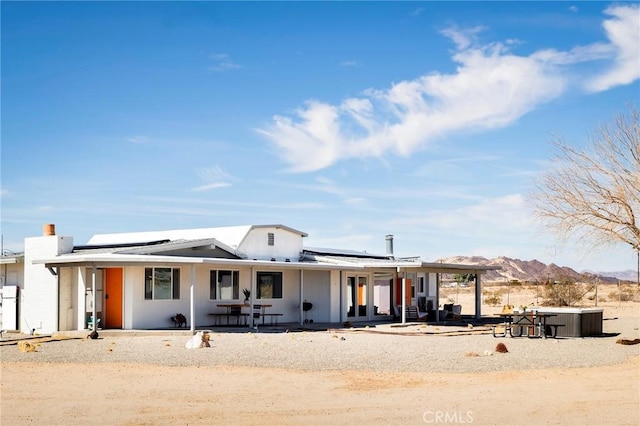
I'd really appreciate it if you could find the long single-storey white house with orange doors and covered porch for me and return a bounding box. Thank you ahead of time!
[5,225,493,333]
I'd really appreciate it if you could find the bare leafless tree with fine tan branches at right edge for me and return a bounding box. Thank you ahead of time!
[532,107,640,252]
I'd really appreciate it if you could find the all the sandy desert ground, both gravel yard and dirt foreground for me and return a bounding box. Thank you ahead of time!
[0,285,640,425]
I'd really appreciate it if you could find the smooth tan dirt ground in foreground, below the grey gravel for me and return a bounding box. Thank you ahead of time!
[0,282,640,425]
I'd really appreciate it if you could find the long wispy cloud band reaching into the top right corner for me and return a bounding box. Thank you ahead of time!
[257,6,640,172]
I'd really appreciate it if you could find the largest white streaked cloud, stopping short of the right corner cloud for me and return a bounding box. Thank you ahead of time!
[258,31,565,172]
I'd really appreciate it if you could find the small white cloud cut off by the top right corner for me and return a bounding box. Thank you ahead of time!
[587,5,640,92]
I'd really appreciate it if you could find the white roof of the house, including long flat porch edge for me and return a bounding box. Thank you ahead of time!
[36,225,500,273]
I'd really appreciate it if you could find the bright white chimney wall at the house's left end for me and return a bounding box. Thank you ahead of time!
[20,235,73,333]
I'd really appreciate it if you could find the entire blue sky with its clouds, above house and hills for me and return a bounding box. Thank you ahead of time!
[1,1,640,271]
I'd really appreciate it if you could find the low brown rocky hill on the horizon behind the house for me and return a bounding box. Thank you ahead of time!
[436,256,634,284]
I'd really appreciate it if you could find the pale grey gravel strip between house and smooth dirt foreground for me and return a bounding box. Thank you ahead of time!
[0,317,640,373]
